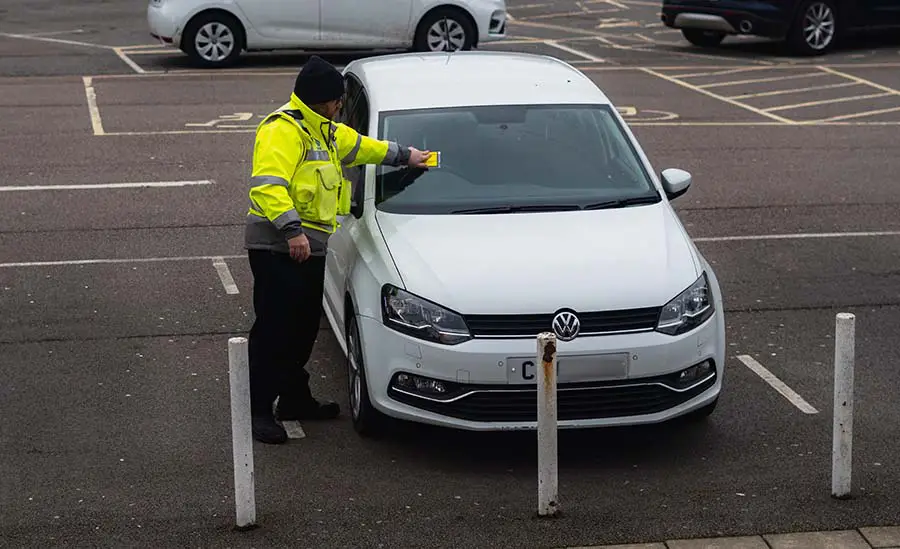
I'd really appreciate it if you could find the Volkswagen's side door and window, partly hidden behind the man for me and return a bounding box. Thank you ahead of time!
[323,74,369,330]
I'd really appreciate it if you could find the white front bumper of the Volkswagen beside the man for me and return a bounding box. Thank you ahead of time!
[360,313,724,431]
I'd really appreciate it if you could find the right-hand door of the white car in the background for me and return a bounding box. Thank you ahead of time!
[322,0,419,48]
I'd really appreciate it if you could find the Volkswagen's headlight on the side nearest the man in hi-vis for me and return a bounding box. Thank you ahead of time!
[381,284,472,345]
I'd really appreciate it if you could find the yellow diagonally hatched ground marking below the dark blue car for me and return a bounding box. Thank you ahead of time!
[656,65,900,124]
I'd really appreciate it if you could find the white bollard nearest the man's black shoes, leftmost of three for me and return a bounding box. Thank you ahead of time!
[228,337,256,530]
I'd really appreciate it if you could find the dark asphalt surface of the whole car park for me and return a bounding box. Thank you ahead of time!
[0,0,900,548]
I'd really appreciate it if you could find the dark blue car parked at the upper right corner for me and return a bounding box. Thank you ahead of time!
[661,0,900,55]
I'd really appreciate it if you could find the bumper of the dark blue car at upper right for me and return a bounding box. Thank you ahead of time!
[660,0,790,38]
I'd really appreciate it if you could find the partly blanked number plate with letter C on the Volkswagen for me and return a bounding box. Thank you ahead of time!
[506,353,630,385]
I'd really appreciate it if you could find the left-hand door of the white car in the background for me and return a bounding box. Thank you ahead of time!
[236,0,321,42]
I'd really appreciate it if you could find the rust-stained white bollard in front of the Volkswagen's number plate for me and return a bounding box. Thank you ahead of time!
[537,332,559,517]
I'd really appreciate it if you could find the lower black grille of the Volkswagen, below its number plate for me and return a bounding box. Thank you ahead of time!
[388,374,716,421]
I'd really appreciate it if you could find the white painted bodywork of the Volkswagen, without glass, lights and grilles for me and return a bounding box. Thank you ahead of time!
[323,52,725,430]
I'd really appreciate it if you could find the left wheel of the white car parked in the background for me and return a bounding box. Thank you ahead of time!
[181,11,244,68]
